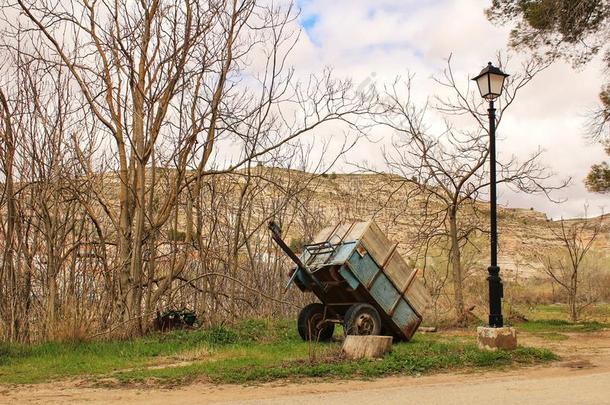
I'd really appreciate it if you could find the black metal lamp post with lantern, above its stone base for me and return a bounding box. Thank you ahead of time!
[472,62,508,328]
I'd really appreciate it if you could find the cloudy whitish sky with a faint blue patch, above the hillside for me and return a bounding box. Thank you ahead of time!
[282,0,610,218]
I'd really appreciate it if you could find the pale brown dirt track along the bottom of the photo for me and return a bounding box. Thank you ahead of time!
[0,330,610,405]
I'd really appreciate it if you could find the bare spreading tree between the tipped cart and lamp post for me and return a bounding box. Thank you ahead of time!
[377,58,566,322]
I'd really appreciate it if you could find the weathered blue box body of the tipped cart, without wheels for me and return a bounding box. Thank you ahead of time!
[287,223,428,340]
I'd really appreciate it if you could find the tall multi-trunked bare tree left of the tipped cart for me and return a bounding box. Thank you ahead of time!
[2,0,372,334]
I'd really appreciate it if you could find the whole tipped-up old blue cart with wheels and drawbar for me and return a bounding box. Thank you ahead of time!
[269,221,431,341]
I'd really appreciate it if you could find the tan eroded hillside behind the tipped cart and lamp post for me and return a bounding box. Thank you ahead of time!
[262,168,610,277]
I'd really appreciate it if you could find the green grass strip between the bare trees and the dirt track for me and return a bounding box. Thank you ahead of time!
[0,320,556,385]
